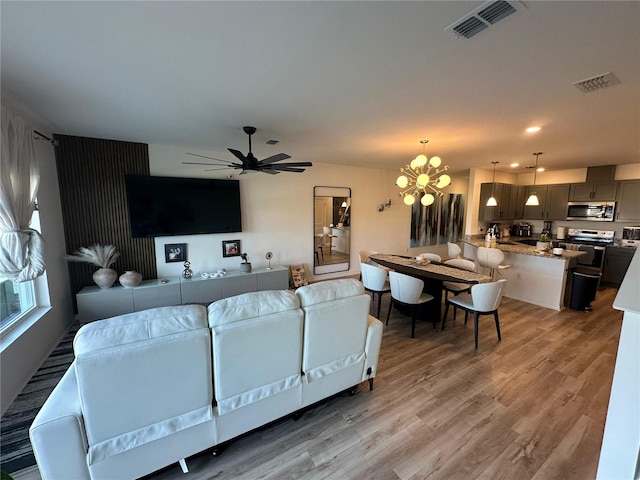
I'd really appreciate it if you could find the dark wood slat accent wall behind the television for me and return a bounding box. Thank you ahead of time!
[54,135,157,305]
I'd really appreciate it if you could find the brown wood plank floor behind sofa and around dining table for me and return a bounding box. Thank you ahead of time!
[142,288,622,480]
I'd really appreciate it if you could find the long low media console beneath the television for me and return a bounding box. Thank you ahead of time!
[76,266,289,324]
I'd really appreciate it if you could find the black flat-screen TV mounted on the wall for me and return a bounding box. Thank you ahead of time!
[125,175,242,238]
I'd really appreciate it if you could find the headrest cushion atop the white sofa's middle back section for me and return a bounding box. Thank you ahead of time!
[208,290,300,327]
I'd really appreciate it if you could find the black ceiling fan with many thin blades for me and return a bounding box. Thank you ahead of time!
[182,127,313,175]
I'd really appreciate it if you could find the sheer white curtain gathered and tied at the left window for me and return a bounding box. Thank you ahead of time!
[0,106,45,282]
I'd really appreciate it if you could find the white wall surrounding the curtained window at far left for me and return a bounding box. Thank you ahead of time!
[0,95,74,413]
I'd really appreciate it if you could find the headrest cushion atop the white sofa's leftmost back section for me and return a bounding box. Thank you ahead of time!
[73,305,208,355]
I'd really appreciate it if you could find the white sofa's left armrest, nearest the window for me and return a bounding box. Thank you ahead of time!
[29,362,91,480]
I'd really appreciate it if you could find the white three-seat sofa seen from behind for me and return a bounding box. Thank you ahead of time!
[30,279,382,480]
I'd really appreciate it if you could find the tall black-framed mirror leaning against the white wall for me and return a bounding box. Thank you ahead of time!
[313,186,351,275]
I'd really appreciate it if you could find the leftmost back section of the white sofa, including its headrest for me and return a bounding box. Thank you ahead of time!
[74,305,214,465]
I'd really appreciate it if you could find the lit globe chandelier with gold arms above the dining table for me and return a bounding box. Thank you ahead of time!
[396,140,451,207]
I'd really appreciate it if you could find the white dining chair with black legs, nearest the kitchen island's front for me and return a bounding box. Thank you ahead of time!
[440,278,507,348]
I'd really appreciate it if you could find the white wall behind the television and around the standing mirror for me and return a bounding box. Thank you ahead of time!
[149,145,468,279]
